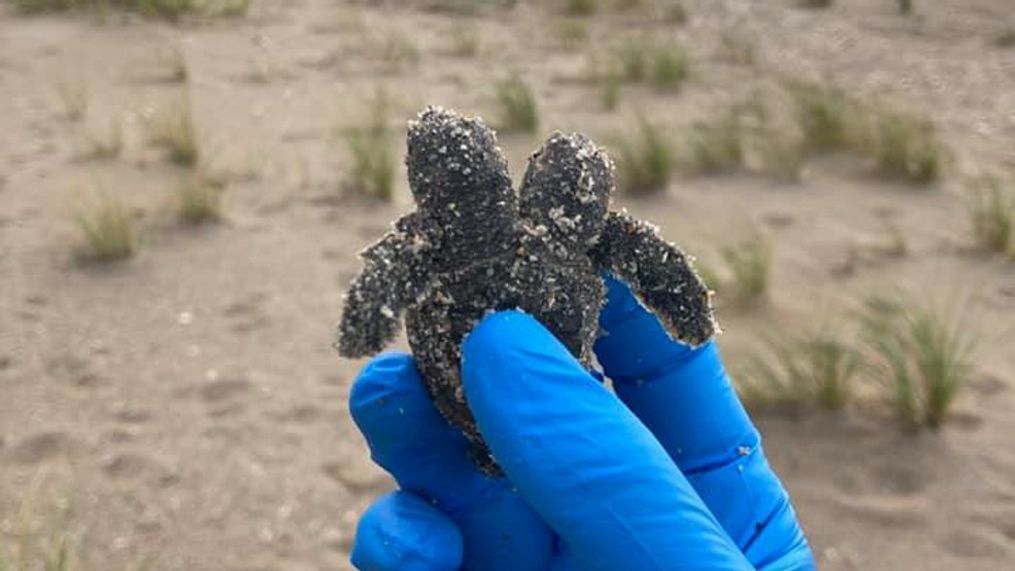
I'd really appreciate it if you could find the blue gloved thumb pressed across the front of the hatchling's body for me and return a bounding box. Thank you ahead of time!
[462,311,750,571]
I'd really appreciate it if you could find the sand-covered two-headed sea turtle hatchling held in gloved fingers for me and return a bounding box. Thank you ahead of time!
[336,108,716,474]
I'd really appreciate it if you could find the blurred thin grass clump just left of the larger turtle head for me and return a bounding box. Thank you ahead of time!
[346,91,397,202]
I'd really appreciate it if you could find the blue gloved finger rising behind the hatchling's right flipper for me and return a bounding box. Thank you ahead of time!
[596,279,809,566]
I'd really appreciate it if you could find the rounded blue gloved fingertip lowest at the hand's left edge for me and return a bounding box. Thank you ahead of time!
[350,492,463,571]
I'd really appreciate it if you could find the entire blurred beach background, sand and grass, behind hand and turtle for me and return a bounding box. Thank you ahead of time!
[0,0,1015,571]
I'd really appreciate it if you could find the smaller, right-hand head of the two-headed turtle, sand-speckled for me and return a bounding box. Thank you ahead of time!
[520,133,613,252]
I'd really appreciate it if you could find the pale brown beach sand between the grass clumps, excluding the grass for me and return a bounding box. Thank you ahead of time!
[0,0,1015,570]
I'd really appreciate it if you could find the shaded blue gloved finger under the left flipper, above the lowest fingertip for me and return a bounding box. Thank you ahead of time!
[349,354,553,571]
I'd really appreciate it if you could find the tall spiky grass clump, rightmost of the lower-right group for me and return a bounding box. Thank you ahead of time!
[861,297,975,429]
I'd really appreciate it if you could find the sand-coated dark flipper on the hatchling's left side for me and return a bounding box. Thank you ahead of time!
[335,213,434,357]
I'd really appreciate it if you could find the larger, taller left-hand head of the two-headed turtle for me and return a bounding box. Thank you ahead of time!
[405,106,517,224]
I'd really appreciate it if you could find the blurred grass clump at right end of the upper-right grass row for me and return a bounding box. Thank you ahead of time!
[871,109,942,185]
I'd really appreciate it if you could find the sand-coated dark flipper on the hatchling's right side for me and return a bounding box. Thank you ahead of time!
[590,212,719,346]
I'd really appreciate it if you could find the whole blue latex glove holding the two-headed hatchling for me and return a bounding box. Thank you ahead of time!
[350,281,815,571]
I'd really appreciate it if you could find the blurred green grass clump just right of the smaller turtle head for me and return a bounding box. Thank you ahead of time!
[614,120,676,195]
